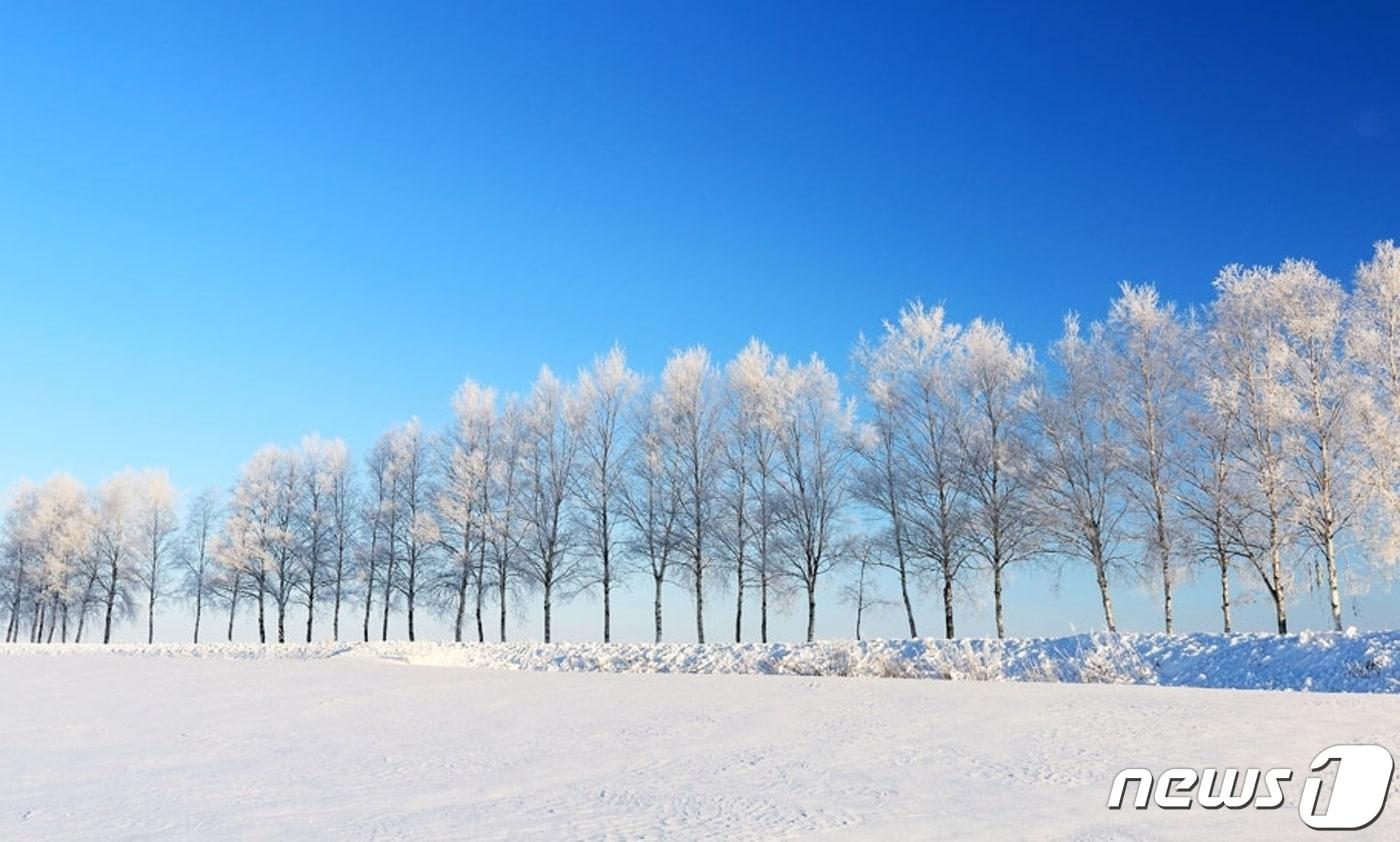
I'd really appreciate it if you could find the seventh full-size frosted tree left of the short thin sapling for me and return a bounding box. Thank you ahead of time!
[521,366,582,643]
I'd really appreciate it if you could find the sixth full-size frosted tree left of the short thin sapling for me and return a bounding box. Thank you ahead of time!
[575,346,641,643]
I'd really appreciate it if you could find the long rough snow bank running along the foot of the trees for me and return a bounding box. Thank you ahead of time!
[8,629,1400,693]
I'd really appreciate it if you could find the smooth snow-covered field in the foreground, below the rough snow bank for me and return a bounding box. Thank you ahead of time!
[0,639,1400,839]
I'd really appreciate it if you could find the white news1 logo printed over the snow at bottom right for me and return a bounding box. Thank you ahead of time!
[1109,745,1396,831]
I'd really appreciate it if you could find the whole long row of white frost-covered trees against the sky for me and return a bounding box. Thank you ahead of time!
[0,242,1400,642]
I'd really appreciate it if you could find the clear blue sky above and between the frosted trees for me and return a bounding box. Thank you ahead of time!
[0,3,1400,635]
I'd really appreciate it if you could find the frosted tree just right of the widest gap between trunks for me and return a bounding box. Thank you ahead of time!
[1036,314,1126,633]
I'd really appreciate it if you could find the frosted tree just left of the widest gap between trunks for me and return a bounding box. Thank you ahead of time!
[955,319,1042,637]
